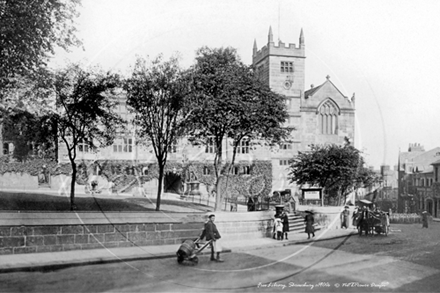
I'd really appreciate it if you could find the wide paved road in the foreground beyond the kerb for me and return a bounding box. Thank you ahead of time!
[0,224,440,292]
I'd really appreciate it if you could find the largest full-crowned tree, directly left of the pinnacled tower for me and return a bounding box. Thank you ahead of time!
[188,47,290,210]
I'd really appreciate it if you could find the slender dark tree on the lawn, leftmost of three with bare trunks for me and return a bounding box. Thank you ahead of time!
[52,65,123,210]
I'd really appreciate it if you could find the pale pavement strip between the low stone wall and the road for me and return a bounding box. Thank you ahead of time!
[0,228,357,273]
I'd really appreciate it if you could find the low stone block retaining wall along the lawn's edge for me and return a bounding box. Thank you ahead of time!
[0,212,272,254]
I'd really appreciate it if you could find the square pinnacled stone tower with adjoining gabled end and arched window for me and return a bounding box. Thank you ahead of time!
[252,28,355,190]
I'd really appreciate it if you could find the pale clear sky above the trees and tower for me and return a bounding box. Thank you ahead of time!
[51,0,440,169]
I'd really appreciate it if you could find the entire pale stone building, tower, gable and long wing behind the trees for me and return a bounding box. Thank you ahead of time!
[0,28,355,202]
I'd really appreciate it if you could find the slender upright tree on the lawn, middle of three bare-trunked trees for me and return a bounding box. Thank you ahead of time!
[125,56,190,211]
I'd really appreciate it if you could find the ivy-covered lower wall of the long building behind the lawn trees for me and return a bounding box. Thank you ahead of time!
[0,157,272,198]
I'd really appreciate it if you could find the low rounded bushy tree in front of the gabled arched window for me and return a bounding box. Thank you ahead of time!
[289,140,378,202]
